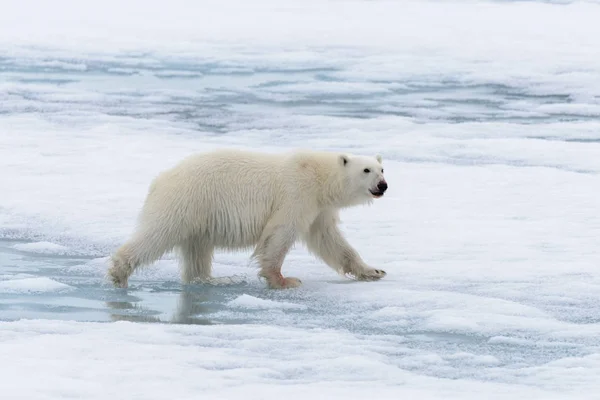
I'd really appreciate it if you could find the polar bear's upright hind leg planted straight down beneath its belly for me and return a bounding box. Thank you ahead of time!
[180,235,214,284]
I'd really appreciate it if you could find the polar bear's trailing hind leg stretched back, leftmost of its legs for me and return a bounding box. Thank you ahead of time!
[108,230,176,288]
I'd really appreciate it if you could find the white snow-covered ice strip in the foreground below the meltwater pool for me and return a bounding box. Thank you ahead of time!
[0,320,600,399]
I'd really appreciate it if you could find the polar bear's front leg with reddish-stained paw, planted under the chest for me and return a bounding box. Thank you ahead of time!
[252,220,302,289]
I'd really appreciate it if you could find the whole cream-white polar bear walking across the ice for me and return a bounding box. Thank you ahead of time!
[108,149,387,288]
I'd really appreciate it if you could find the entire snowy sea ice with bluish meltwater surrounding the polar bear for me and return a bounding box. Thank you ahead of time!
[0,0,600,400]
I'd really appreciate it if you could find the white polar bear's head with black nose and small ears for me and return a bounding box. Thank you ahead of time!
[338,154,388,206]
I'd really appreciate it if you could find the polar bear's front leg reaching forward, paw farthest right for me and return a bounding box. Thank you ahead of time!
[303,211,387,281]
